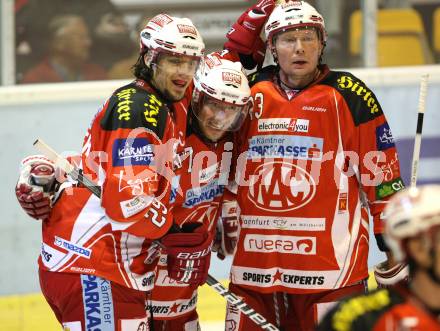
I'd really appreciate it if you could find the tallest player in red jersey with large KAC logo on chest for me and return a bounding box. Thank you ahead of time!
[226,1,403,331]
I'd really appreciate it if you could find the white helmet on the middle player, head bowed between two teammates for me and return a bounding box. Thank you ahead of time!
[192,53,252,131]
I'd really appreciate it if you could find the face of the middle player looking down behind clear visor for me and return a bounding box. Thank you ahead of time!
[197,97,242,141]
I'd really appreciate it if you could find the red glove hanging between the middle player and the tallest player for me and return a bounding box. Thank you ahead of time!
[212,201,238,260]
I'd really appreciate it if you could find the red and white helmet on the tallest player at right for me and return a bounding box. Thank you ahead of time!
[264,1,327,46]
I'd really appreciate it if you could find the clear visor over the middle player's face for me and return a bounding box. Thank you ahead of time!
[193,94,250,131]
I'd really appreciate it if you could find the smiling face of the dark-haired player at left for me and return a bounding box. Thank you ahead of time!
[153,53,199,101]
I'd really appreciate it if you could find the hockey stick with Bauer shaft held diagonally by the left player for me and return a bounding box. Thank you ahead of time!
[34,139,280,331]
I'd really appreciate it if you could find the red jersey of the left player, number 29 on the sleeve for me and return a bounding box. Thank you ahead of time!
[39,80,191,291]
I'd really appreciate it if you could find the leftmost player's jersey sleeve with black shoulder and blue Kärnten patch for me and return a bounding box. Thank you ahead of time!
[83,85,174,239]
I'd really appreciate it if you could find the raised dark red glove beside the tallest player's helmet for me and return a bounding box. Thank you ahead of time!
[224,0,275,64]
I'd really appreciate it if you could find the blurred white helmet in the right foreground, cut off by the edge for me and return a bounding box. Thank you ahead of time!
[384,185,440,261]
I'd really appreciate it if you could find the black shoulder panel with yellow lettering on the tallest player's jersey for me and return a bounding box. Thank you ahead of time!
[321,71,383,126]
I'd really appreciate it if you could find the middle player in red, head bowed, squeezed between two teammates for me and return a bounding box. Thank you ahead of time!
[148,53,251,331]
